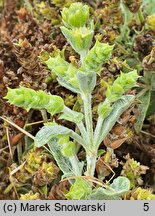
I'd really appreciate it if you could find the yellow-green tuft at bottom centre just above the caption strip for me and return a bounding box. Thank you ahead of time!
[65,178,92,200]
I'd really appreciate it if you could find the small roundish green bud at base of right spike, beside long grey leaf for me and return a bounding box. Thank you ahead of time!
[98,103,112,119]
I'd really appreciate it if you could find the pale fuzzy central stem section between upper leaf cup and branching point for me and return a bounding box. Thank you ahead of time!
[81,94,93,147]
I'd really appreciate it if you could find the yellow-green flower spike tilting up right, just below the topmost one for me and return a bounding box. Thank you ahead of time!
[81,41,113,73]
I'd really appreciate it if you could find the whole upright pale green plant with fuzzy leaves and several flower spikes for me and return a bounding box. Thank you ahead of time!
[5,3,139,199]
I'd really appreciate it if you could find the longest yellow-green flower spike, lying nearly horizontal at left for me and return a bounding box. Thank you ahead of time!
[4,87,64,115]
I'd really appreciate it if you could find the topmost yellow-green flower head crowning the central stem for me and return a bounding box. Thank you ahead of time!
[61,3,89,28]
